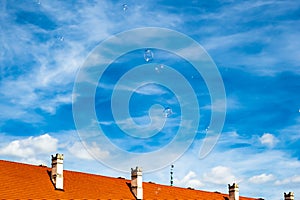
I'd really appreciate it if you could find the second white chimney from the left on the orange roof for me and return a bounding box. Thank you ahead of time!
[131,167,143,199]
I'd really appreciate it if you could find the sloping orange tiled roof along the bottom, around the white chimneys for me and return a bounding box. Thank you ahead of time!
[0,160,254,200]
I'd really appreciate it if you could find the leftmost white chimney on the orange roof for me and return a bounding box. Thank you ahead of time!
[51,153,64,190]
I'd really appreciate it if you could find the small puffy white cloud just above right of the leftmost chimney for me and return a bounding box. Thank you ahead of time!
[68,142,109,160]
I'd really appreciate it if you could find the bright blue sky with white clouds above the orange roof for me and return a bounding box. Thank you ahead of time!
[0,0,300,199]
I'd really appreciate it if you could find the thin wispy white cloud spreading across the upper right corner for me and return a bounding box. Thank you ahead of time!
[198,1,300,76]
